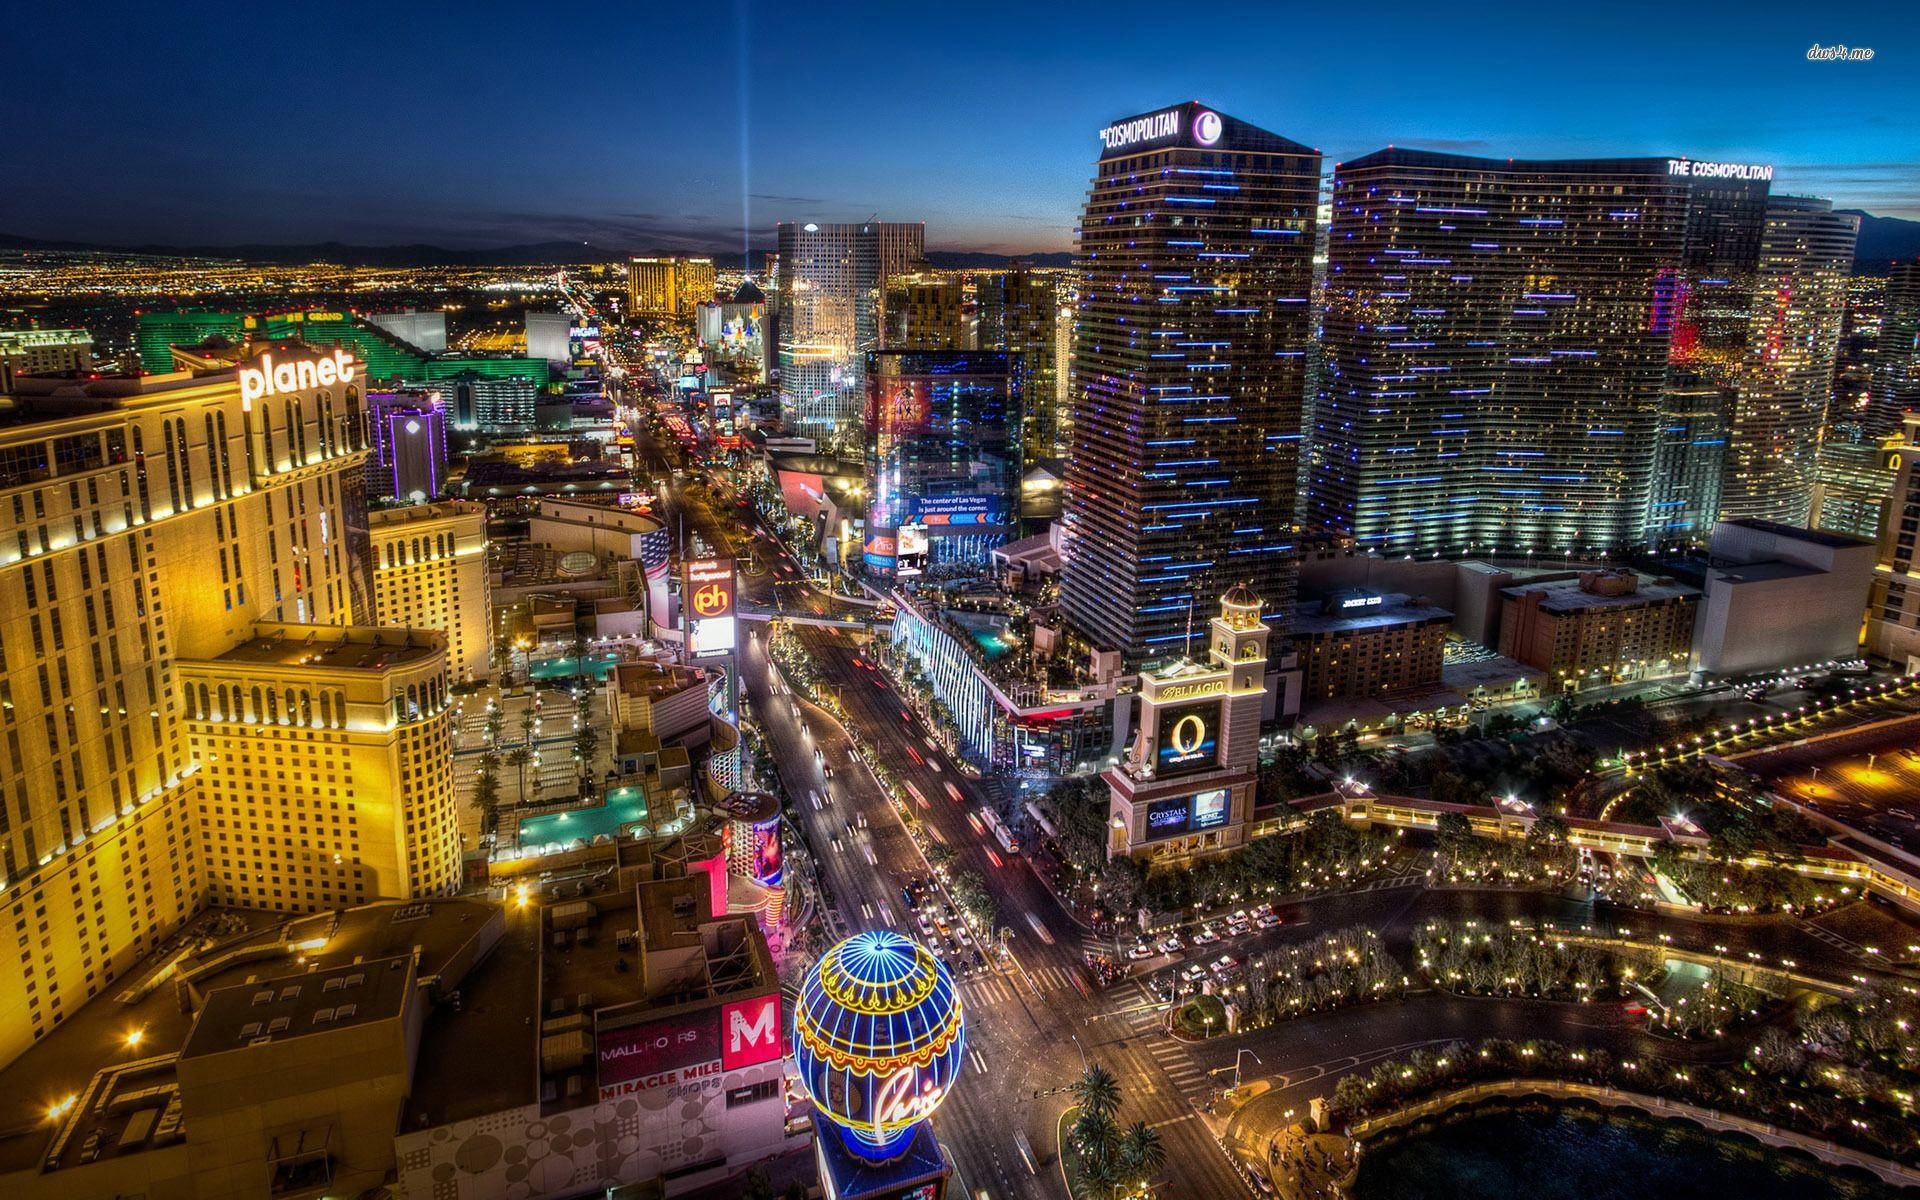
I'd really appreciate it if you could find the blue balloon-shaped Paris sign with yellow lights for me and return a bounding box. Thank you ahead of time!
[793,929,966,1160]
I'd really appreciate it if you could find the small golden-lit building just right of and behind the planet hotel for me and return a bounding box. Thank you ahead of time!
[367,499,493,682]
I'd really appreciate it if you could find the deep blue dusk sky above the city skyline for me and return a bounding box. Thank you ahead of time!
[0,0,1920,252]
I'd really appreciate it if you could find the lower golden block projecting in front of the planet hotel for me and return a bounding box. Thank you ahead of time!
[180,624,461,912]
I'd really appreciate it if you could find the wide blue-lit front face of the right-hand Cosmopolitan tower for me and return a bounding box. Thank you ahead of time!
[1306,150,1690,557]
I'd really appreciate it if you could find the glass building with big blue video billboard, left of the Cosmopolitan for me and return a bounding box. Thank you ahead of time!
[864,349,1025,570]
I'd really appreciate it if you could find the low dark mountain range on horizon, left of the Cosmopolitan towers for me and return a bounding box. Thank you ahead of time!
[0,234,1073,269]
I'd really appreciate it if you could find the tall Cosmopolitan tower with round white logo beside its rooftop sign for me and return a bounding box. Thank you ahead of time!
[1060,102,1321,662]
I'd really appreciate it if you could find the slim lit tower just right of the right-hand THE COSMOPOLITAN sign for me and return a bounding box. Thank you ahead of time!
[1720,196,1858,524]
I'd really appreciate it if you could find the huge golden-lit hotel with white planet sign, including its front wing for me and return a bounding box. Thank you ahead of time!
[0,342,461,1062]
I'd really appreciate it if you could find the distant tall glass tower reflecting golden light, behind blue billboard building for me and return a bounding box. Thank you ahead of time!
[776,221,925,444]
